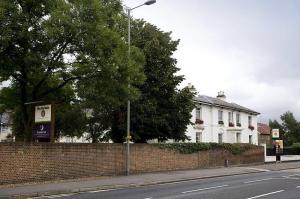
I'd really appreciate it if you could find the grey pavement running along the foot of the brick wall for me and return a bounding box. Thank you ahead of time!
[0,162,300,198]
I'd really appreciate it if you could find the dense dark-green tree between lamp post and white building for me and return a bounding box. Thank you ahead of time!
[111,20,193,142]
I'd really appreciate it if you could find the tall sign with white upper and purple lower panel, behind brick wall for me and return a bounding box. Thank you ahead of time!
[32,103,55,142]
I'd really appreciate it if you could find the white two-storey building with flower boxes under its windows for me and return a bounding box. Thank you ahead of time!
[186,92,260,144]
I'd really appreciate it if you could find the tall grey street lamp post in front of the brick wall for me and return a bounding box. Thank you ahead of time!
[126,0,156,175]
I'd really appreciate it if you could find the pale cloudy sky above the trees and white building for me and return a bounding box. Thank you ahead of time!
[123,0,300,122]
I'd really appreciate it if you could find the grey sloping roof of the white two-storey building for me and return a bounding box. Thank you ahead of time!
[193,95,260,115]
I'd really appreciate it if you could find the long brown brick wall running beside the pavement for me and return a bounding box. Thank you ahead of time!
[0,143,264,185]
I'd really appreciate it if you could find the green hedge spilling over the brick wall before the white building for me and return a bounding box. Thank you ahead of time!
[155,143,257,155]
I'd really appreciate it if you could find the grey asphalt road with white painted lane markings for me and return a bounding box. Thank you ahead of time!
[31,169,300,199]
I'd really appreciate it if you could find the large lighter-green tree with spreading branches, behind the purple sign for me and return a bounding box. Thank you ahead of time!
[0,0,141,141]
